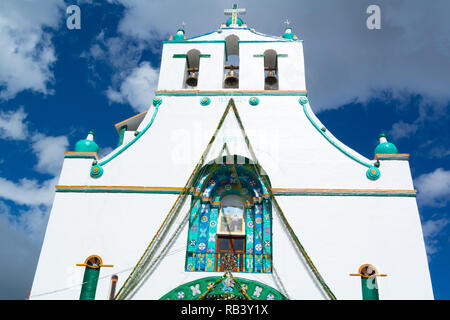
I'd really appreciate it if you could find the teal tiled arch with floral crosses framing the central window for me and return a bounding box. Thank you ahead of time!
[185,156,272,273]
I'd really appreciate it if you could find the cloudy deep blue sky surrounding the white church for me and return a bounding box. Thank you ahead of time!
[0,0,450,299]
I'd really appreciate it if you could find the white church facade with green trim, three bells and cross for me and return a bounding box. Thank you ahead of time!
[30,6,433,300]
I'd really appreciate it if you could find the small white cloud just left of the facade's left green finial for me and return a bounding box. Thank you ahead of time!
[32,134,69,176]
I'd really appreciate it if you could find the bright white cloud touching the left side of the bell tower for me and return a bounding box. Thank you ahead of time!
[106,62,158,112]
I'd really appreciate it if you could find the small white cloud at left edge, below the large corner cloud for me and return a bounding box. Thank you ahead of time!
[0,108,28,140]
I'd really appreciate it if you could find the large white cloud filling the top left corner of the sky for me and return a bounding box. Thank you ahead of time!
[0,0,64,99]
